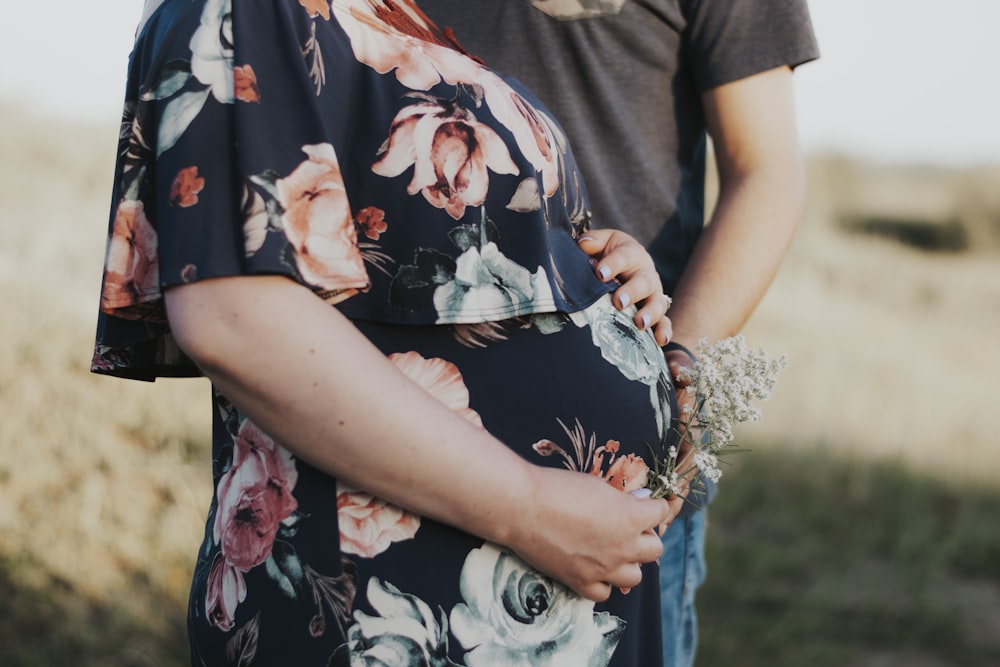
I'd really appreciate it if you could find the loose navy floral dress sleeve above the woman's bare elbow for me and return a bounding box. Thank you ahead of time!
[92,0,370,380]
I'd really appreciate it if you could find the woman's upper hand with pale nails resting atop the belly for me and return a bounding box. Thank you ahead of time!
[577,229,673,346]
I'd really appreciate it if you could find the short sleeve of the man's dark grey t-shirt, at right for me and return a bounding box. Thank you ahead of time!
[685,0,819,92]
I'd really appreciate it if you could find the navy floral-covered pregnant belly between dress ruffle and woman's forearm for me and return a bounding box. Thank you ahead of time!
[355,297,676,472]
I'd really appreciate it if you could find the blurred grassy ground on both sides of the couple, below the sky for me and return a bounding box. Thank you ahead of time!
[0,108,1000,667]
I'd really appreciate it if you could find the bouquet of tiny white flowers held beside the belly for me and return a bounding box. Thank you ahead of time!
[644,334,787,498]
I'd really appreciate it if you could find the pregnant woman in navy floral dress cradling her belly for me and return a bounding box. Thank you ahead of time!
[93,0,677,667]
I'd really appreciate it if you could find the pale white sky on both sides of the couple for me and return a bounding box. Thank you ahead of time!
[0,0,1000,165]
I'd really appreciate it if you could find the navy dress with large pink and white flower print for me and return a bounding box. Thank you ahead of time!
[93,0,676,667]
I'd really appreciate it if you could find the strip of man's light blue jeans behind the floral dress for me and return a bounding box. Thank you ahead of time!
[660,508,705,667]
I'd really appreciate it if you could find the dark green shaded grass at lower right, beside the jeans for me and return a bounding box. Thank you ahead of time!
[698,447,1000,667]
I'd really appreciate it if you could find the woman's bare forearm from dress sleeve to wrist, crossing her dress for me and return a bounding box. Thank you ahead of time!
[167,277,533,541]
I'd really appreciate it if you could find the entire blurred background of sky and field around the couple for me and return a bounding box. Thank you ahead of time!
[0,0,1000,667]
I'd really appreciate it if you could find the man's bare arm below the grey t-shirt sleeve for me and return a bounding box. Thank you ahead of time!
[670,67,805,349]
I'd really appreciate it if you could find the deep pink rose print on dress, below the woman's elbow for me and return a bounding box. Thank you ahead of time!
[212,420,298,572]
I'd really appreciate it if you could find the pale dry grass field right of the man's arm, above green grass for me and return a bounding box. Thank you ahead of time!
[746,158,1000,488]
